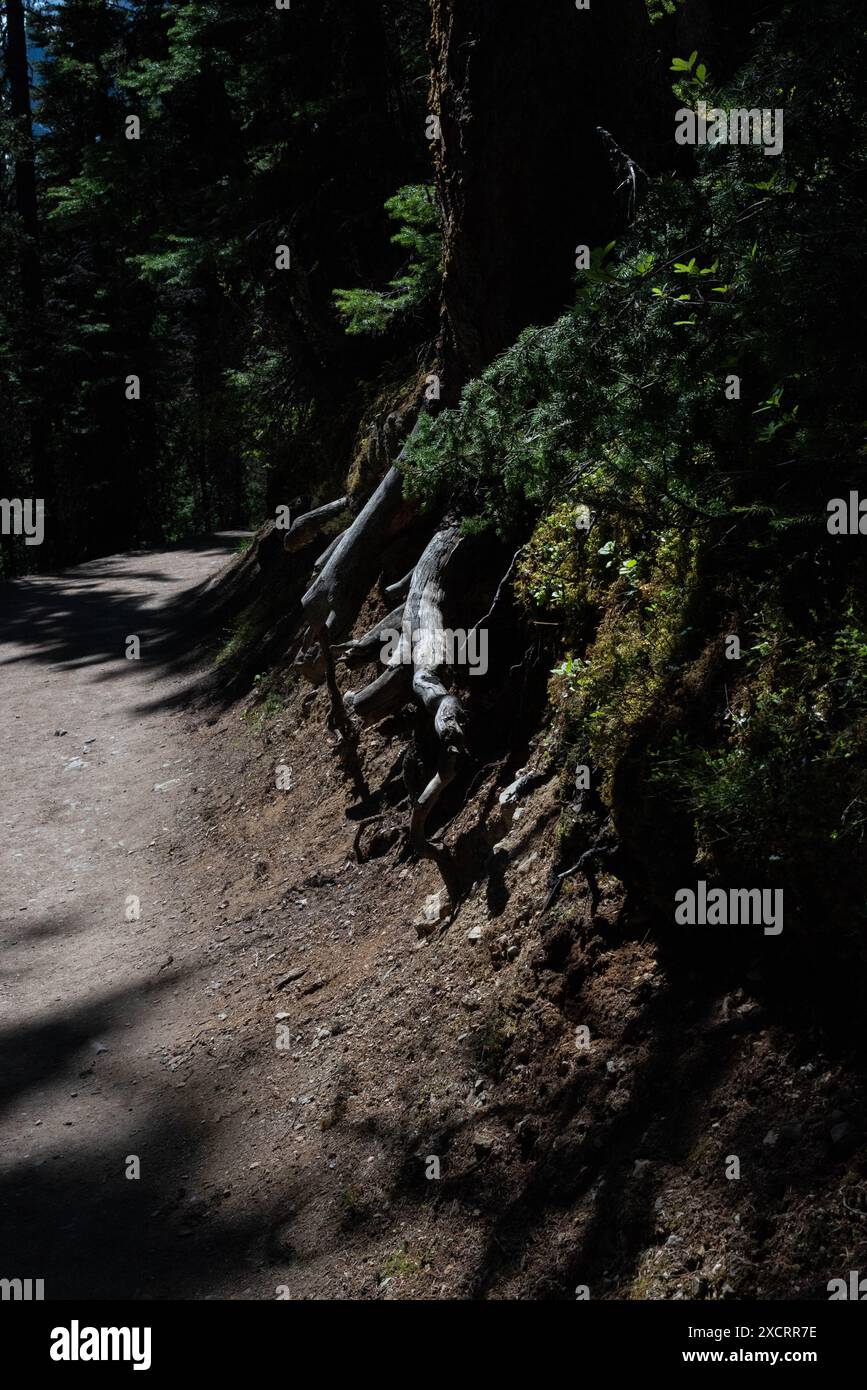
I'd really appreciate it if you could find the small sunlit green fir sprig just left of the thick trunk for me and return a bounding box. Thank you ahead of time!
[333,183,442,334]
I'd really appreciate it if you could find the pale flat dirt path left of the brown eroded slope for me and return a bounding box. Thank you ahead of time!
[0,534,257,1297]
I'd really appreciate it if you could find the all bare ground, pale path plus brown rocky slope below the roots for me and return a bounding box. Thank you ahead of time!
[0,537,867,1300]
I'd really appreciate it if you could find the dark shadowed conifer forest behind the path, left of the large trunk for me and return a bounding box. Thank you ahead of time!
[0,0,431,566]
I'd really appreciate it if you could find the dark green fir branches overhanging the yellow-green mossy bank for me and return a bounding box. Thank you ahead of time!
[406,0,866,543]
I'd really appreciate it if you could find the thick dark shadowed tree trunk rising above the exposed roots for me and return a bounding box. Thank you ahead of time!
[431,0,671,391]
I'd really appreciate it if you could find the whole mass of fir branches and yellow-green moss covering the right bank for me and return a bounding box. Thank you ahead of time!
[403,0,867,874]
